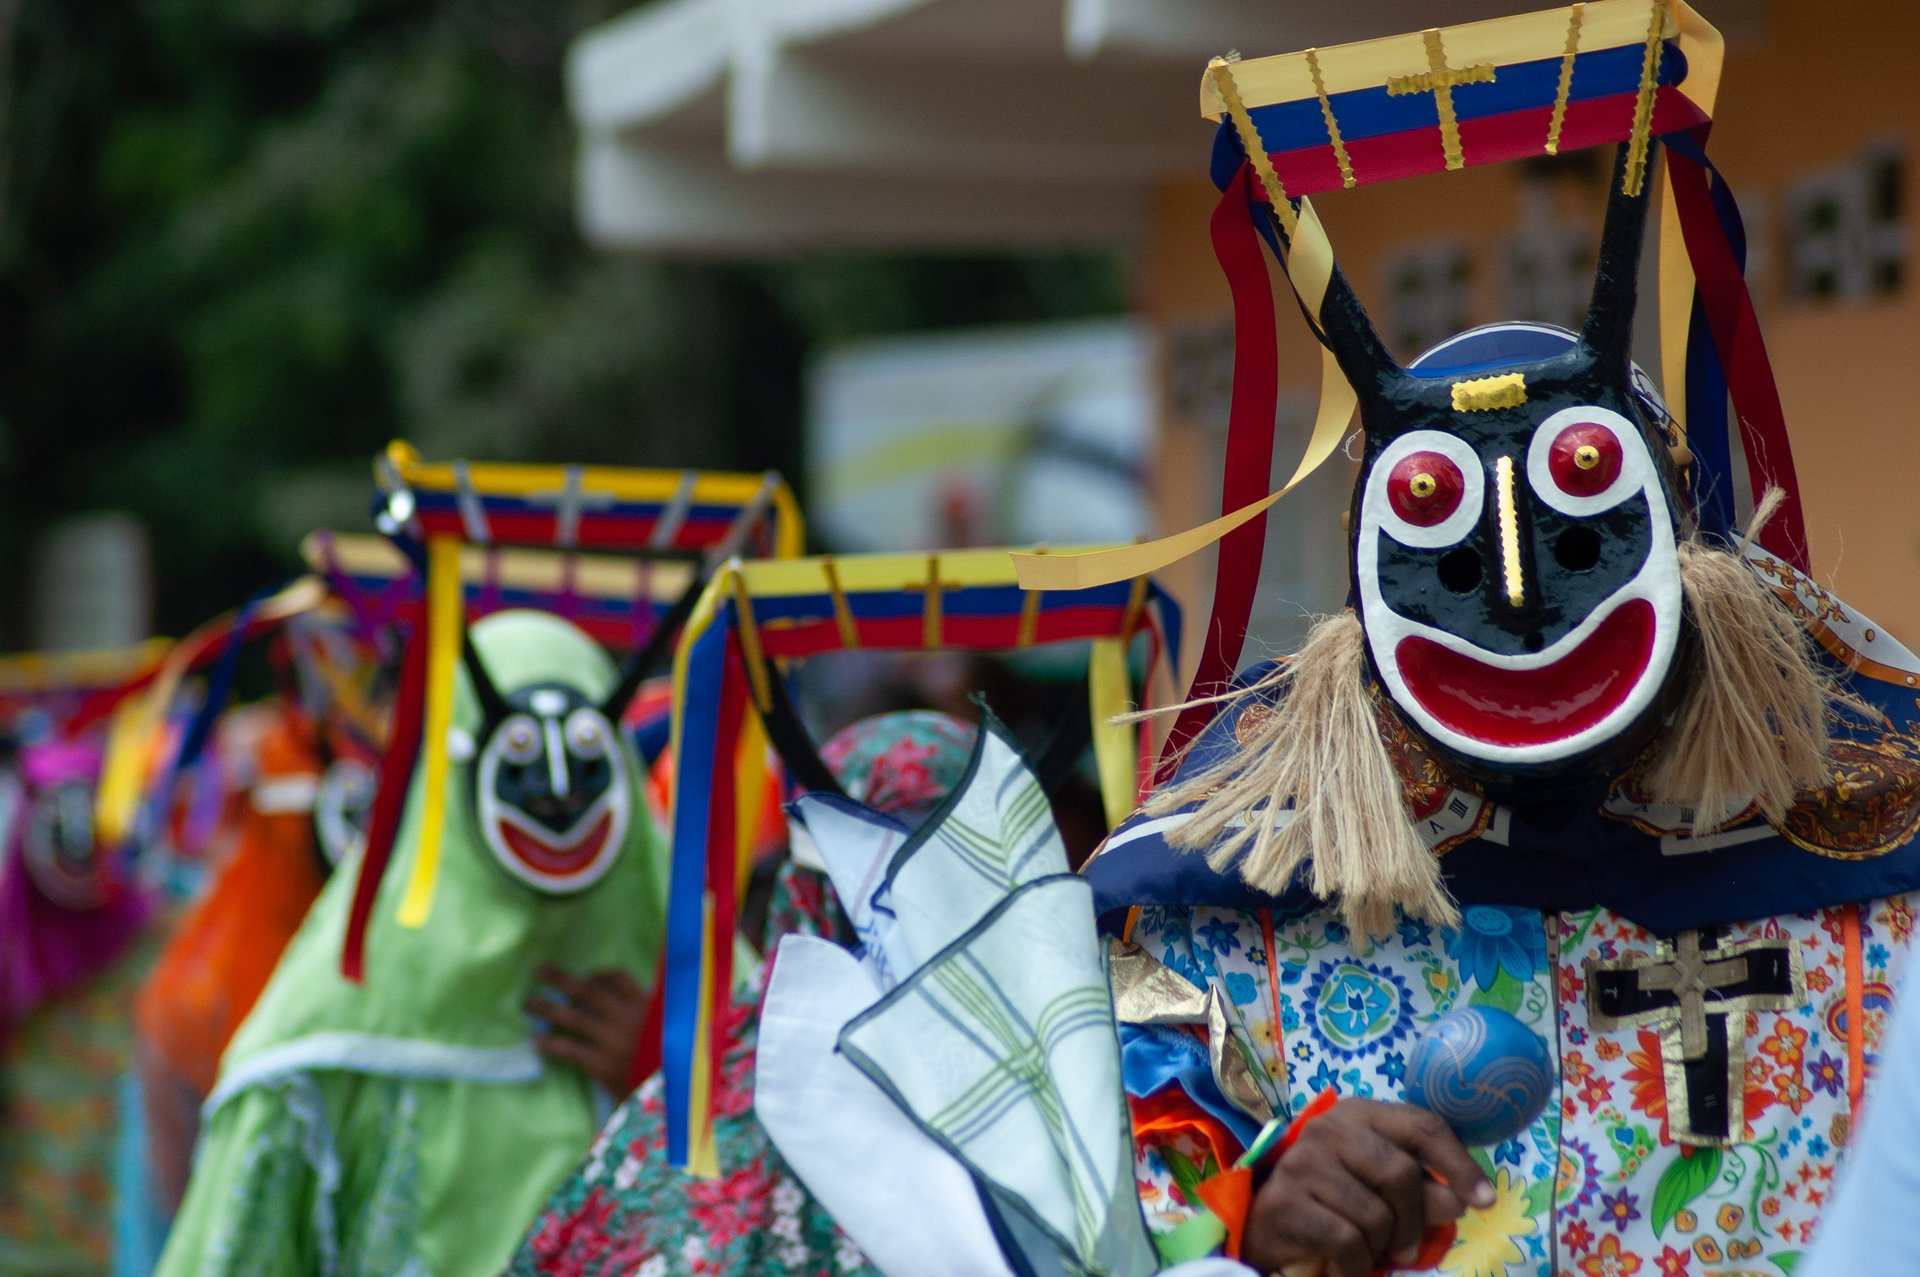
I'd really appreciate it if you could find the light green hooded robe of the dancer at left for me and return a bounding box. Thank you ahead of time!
[157,613,666,1277]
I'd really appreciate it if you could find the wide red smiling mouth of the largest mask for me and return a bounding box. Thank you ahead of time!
[1394,599,1655,749]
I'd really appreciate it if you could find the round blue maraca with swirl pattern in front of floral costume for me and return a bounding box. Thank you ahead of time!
[1407,1006,1553,1148]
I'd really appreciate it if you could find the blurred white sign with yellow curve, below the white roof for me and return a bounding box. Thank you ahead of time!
[806,321,1152,551]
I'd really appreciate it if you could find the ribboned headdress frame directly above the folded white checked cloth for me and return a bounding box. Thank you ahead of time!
[662,549,1179,1173]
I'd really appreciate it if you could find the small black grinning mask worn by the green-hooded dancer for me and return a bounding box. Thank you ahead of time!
[465,639,636,895]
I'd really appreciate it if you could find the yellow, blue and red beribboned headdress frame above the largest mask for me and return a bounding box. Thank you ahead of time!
[1020,0,1805,768]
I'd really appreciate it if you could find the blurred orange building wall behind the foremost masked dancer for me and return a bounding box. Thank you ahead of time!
[1140,0,1920,649]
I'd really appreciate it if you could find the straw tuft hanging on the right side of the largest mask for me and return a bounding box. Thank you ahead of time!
[1644,488,1864,831]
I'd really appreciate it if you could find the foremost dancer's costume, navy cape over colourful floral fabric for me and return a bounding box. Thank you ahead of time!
[1087,591,1920,1277]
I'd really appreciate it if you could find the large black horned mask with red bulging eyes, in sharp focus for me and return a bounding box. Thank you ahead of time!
[1323,146,1684,782]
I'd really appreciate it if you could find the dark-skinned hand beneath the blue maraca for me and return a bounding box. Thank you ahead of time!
[1240,1100,1494,1277]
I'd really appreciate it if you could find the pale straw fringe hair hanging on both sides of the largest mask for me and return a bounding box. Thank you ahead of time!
[1129,490,1850,935]
